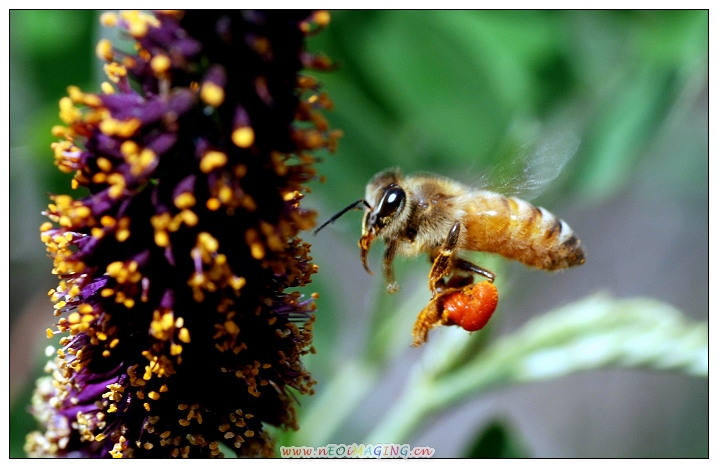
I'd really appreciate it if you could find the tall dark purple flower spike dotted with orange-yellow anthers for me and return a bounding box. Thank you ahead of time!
[26,11,340,457]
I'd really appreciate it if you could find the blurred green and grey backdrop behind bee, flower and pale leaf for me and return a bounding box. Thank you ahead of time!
[10,11,708,457]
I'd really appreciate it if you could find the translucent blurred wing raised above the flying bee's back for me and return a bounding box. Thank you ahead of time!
[481,132,581,200]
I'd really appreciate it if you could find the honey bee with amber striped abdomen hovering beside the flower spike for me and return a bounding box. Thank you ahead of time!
[315,133,585,298]
